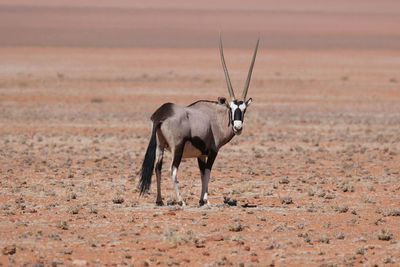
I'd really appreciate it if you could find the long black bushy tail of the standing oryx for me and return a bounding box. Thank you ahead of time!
[139,124,159,195]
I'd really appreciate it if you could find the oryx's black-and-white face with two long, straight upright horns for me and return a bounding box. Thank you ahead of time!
[219,34,260,135]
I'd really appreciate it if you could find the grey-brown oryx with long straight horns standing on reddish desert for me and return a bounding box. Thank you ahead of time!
[139,36,260,206]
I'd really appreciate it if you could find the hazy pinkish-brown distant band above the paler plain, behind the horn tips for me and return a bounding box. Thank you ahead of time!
[0,0,400,50]
